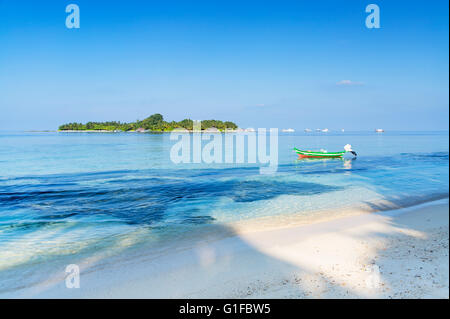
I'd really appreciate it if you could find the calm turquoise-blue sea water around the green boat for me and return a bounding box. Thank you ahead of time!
[0,132,449,288]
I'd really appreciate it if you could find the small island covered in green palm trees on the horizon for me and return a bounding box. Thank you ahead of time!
[58,113,238,132]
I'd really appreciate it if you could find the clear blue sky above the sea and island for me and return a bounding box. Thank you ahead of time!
[0,0,449,130]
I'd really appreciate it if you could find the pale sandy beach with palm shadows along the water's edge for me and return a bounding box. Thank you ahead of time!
[0,199,449,298]
